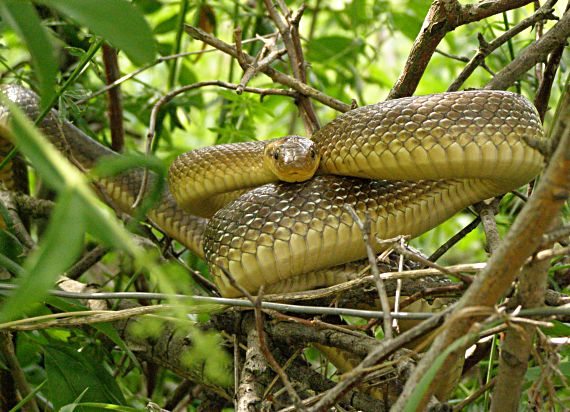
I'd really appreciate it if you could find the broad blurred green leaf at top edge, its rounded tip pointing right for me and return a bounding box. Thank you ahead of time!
[38,0,157,65]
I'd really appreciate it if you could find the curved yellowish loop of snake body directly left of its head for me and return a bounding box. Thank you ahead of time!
[168,141,278,217]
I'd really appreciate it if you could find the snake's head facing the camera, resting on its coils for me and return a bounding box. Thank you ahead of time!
[263,136,321,182]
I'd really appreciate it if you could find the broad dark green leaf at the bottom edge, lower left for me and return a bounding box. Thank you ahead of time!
[44,345,126,411]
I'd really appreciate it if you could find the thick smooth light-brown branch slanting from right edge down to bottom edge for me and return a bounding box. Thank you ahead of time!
[395,76,570,410]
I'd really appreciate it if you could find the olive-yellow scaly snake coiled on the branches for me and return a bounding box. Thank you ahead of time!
[0,85,545,297]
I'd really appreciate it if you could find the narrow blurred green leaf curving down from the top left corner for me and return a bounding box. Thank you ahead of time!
[0,0,58,109]
